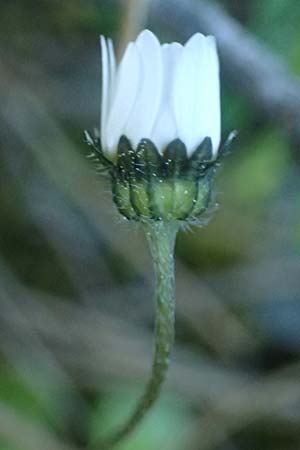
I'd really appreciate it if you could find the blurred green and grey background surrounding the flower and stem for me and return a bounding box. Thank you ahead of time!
[0,0,300,450]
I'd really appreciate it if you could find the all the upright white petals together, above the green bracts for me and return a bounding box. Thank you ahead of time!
[100,30,221,156]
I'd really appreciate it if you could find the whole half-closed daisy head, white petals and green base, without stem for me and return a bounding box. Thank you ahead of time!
[86,30,237,221]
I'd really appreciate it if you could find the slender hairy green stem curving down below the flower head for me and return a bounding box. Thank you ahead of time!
[101,221,178,450]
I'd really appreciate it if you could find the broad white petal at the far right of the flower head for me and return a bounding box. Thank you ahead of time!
[173,33,220,153]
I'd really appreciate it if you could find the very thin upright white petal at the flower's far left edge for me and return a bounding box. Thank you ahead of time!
[100,36,110,139]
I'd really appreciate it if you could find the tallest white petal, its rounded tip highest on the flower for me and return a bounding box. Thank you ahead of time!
[125,30,162,147]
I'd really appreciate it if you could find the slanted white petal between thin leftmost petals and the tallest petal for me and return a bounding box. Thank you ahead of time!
[104,42,141,152]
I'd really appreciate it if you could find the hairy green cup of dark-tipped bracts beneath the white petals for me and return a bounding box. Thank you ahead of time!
[86,132,236,222]
